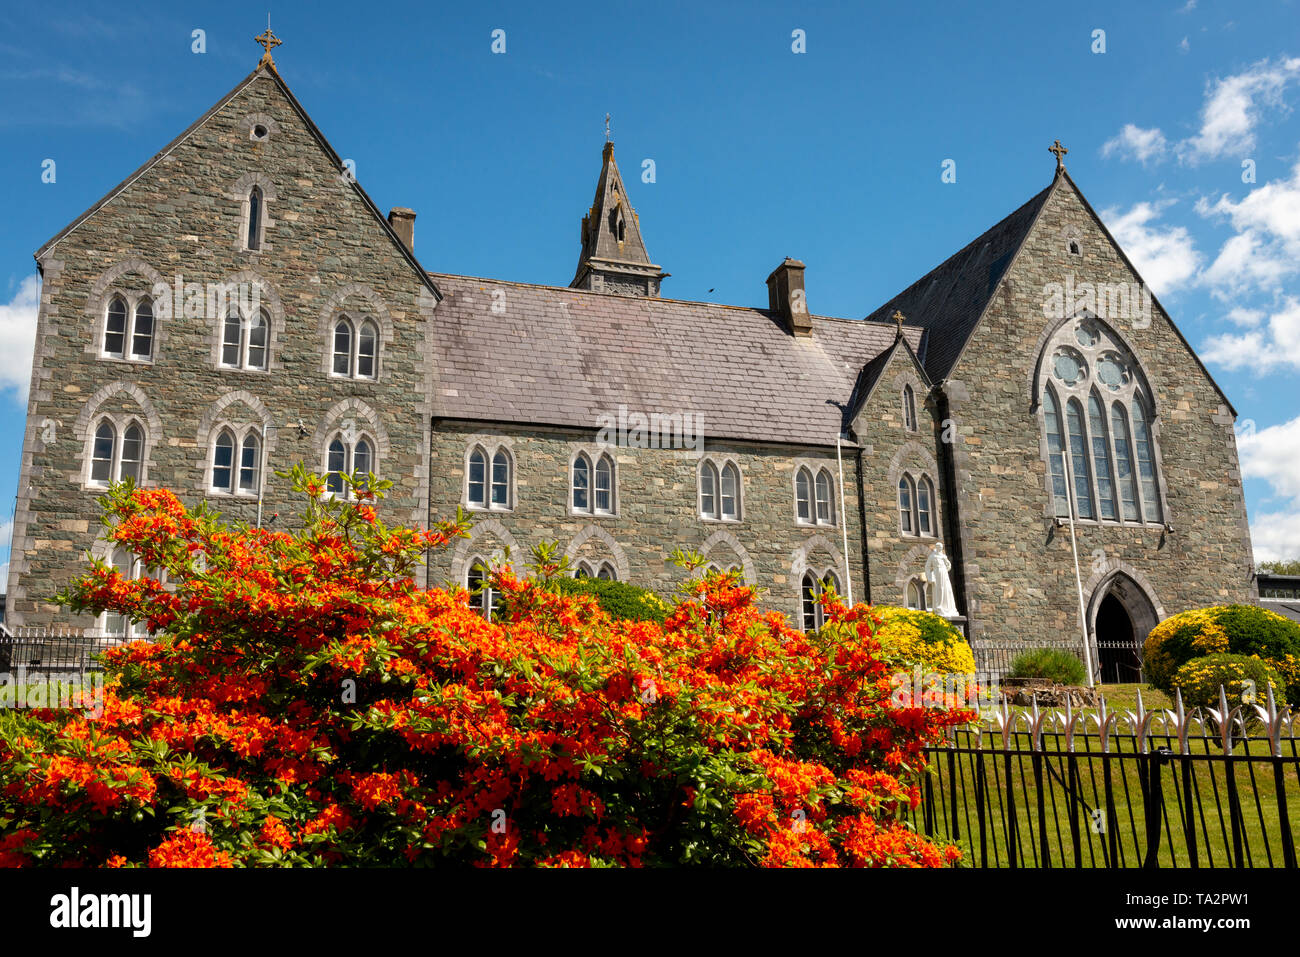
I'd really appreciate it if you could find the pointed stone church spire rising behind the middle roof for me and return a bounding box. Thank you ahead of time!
[569,132,668,298]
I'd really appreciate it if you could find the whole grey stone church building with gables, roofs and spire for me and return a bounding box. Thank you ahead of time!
[8,42,1255,670]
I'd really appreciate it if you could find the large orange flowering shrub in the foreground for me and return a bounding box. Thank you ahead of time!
[0,469,974,867]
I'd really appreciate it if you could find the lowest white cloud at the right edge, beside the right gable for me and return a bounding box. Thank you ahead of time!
[1236,416,1300,562]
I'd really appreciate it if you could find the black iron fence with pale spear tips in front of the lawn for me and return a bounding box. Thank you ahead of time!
[913,702,1300,869]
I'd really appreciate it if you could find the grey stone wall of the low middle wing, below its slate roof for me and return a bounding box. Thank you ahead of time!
[429,423,862,615]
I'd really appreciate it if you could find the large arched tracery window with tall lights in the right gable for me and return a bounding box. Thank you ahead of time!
[1037,315,1164,524]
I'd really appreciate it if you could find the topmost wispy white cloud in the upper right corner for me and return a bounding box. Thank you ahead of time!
[1179,57,1300,164]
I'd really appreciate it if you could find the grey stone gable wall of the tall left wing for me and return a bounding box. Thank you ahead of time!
[8,74,433,627]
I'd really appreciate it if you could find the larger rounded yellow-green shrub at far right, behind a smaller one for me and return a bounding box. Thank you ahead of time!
[1143,605,1300,705]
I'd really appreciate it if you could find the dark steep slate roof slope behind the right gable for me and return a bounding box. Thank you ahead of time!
[867,183,1054,382]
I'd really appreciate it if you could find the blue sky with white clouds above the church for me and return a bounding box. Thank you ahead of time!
[0,0,1300,580]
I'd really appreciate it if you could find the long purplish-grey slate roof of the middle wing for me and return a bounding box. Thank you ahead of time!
[430,273,923,446]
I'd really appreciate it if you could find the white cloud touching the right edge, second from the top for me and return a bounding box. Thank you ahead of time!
[1196,155,1300,298]
